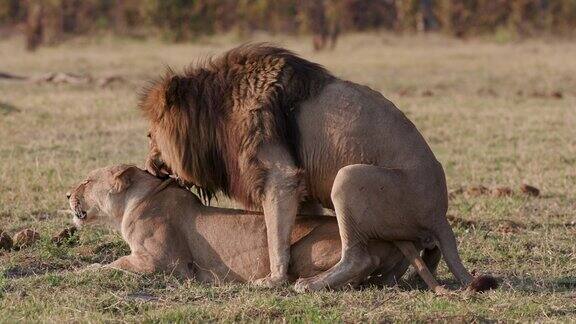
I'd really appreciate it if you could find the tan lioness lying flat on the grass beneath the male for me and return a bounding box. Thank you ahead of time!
[68,165,442,292]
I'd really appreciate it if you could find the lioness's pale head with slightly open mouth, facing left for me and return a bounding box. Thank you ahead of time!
[67,165,140,226]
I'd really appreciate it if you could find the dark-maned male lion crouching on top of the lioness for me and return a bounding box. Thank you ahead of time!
[140,45,496,290]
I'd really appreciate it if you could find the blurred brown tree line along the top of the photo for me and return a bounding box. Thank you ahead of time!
[0,0,576,50]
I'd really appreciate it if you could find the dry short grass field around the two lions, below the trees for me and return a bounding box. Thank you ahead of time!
[0,34,576,322]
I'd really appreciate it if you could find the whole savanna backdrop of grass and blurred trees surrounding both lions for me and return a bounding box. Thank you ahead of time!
[0,0,576,322]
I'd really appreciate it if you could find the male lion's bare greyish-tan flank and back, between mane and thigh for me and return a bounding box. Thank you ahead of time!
[297,81,436,208]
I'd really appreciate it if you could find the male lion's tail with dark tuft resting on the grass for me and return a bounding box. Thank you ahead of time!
[435,217,498,291]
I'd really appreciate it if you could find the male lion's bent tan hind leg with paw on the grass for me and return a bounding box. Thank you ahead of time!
[295,164,426,291]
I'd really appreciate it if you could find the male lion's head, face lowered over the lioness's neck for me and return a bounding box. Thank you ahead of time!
[140,71,228,204]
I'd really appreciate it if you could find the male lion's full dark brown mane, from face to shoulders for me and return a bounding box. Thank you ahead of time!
[140,44,333,206]
